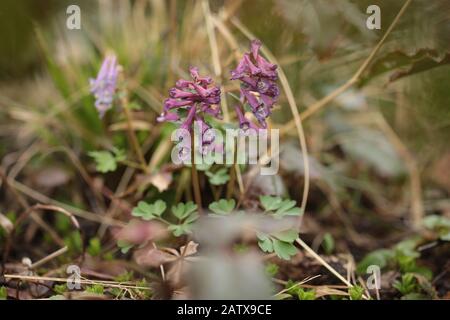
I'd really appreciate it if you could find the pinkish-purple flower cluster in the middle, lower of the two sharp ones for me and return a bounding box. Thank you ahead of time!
[157,67,221,153]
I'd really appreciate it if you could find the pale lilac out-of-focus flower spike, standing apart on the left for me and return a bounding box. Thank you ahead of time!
[89,55,120,118]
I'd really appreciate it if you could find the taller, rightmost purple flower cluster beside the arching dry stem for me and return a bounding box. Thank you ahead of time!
[231,40,280,128]
